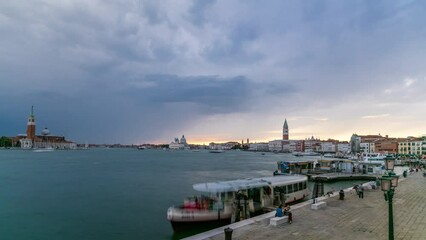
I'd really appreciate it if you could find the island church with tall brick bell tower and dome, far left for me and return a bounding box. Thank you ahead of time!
[13,107,77,149]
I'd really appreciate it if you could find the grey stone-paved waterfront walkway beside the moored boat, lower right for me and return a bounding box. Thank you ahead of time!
[192,172,426,240]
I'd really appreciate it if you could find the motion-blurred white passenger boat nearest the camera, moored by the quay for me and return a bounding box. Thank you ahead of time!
[167,175,308,231]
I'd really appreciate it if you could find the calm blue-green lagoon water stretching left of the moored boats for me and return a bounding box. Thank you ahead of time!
[0,148,366,240]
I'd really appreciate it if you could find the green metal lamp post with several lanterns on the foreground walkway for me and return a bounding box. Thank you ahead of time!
[381,156,398,240]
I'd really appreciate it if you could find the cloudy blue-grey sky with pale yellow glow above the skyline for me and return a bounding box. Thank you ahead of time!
[0,0,426,144]
